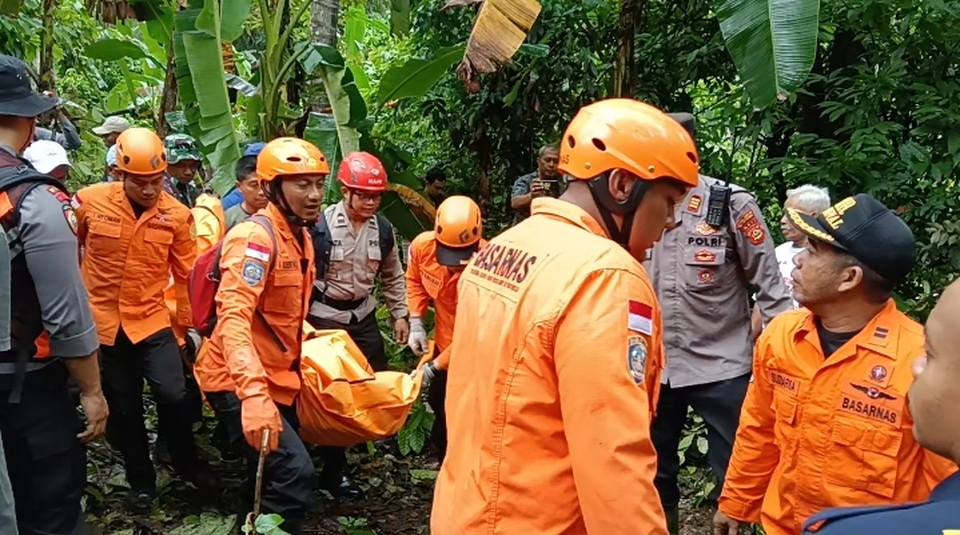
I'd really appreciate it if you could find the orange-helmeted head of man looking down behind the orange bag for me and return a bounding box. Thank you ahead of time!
[433,195,483,266]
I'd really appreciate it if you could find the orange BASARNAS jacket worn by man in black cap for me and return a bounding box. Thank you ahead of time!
[720,300,957,535]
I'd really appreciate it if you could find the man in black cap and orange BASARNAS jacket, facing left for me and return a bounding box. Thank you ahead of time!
[714,194,957,535]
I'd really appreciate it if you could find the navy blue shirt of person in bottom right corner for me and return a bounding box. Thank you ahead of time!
[803,473,960,535]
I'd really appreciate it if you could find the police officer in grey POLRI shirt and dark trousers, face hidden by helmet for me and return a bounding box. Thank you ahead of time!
[645,114,791,534]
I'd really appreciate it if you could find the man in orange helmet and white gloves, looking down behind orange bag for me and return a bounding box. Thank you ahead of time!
[407,195,486,464]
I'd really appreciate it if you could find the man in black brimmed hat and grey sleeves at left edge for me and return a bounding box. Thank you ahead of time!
[0,55,107,534]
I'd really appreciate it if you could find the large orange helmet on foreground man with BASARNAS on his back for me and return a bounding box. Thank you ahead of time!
[559,98,699,187]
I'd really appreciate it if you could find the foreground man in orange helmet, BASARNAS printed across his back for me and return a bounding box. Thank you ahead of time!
[431,99,698,535]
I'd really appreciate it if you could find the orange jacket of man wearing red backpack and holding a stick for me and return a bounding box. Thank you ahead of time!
[194,204,315,405]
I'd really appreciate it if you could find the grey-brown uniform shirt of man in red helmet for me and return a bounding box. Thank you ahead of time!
[310,201,410,324]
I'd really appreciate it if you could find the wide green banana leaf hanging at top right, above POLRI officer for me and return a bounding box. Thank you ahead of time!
[716,0,820,108]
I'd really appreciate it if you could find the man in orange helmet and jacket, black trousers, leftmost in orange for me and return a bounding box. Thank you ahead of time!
[74,128,219,512]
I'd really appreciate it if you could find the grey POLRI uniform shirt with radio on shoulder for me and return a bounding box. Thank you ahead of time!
[645,176,792,388]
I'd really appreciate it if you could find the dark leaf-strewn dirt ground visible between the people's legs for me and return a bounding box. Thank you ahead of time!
[84,428,713,535]
